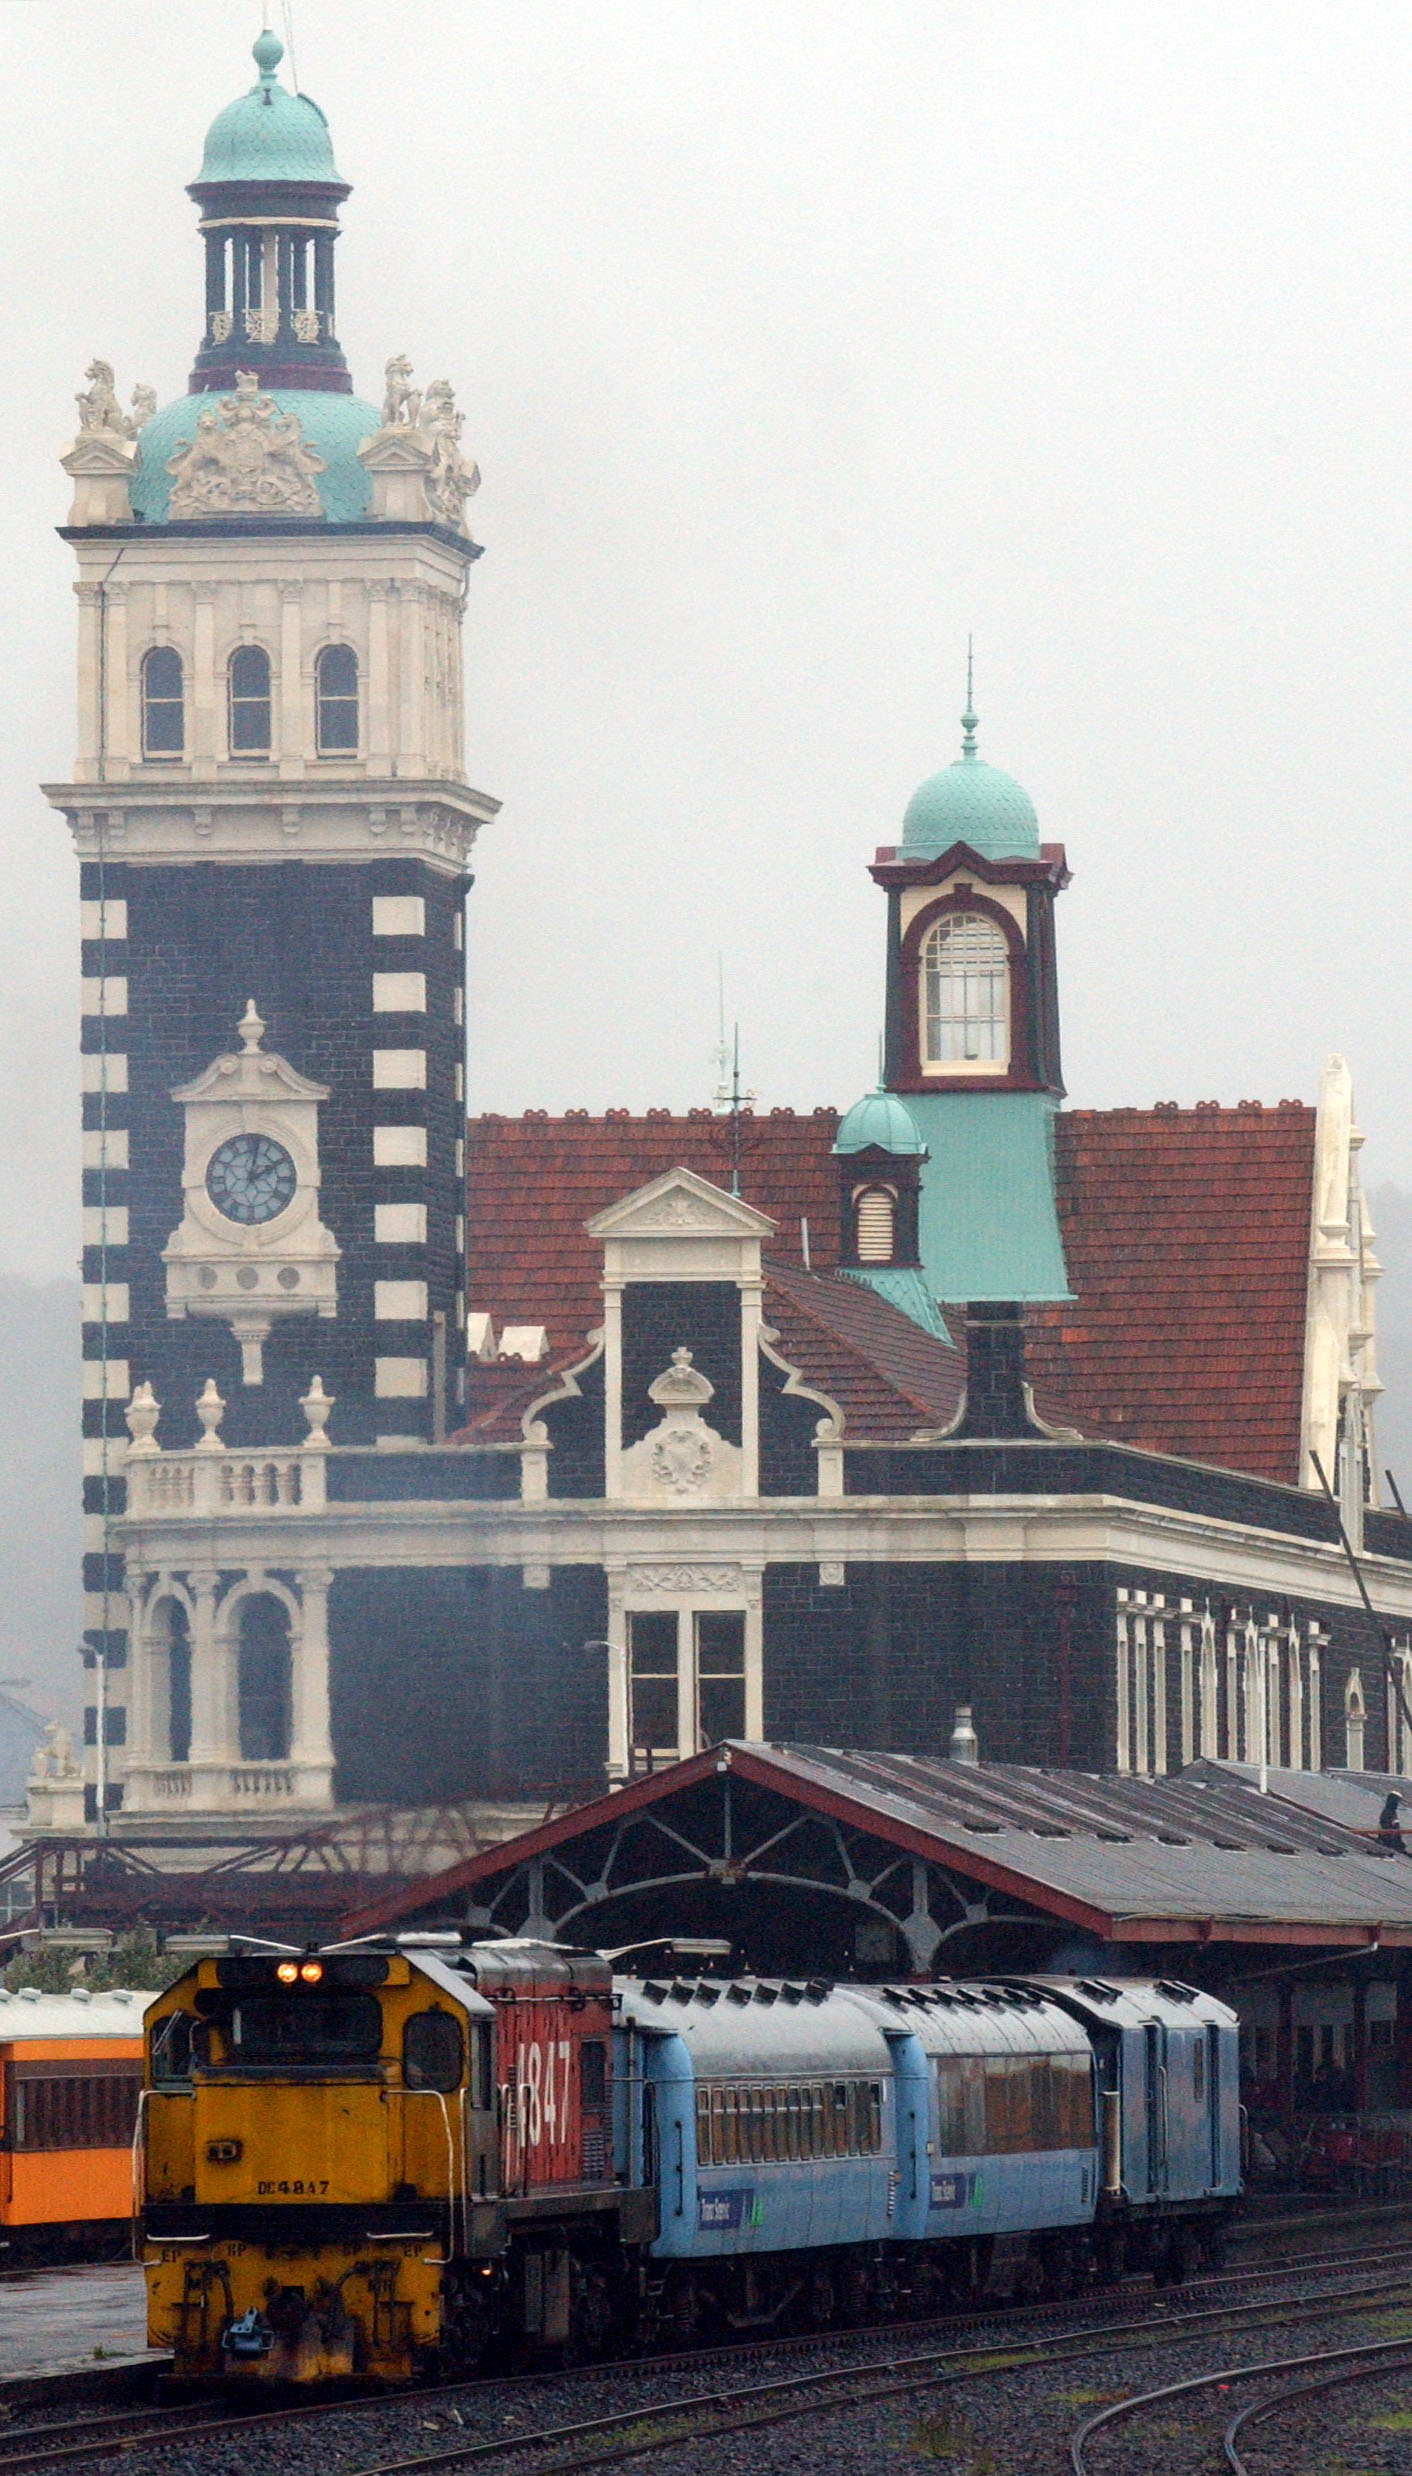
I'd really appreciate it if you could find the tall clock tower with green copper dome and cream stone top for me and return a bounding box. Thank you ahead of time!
[47,32,495,1805]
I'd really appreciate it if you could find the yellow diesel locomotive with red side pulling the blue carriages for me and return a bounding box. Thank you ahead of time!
[139,1939,656,2382]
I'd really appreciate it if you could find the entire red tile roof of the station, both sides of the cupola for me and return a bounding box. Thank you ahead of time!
[463,1102,1315,1483]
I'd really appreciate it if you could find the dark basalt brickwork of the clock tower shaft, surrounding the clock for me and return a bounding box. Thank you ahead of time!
[82,859,463,1448]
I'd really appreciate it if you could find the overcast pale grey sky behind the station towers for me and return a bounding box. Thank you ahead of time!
[0,0,1412,1275]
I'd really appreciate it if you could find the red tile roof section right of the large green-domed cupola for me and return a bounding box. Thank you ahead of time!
[1028,1102,1315,1486]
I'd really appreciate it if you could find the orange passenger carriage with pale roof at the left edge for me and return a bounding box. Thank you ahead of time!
[0,1986,149,2263]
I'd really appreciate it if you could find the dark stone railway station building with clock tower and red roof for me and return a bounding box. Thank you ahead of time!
[32,19,1412,1840]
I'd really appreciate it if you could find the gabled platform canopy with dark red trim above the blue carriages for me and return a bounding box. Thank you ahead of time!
[331,1743,1412,1973]
